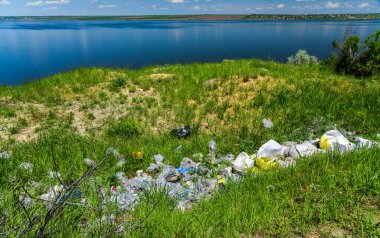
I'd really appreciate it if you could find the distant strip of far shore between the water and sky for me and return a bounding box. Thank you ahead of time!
[0,13,380,21]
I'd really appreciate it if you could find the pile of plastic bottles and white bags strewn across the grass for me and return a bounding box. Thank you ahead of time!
[4,128,380,210]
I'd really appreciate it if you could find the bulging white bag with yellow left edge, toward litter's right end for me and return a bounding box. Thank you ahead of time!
[319,130,355,153]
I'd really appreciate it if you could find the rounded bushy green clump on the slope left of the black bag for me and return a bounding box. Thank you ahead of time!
[107,118,141,138]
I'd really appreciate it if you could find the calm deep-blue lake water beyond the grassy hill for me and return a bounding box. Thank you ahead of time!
[0,20,380,85]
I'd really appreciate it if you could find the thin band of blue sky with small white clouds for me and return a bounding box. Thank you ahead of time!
[0,0,380,16]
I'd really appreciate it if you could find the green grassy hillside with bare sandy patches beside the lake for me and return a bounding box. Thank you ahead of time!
[0,60,380,237]
